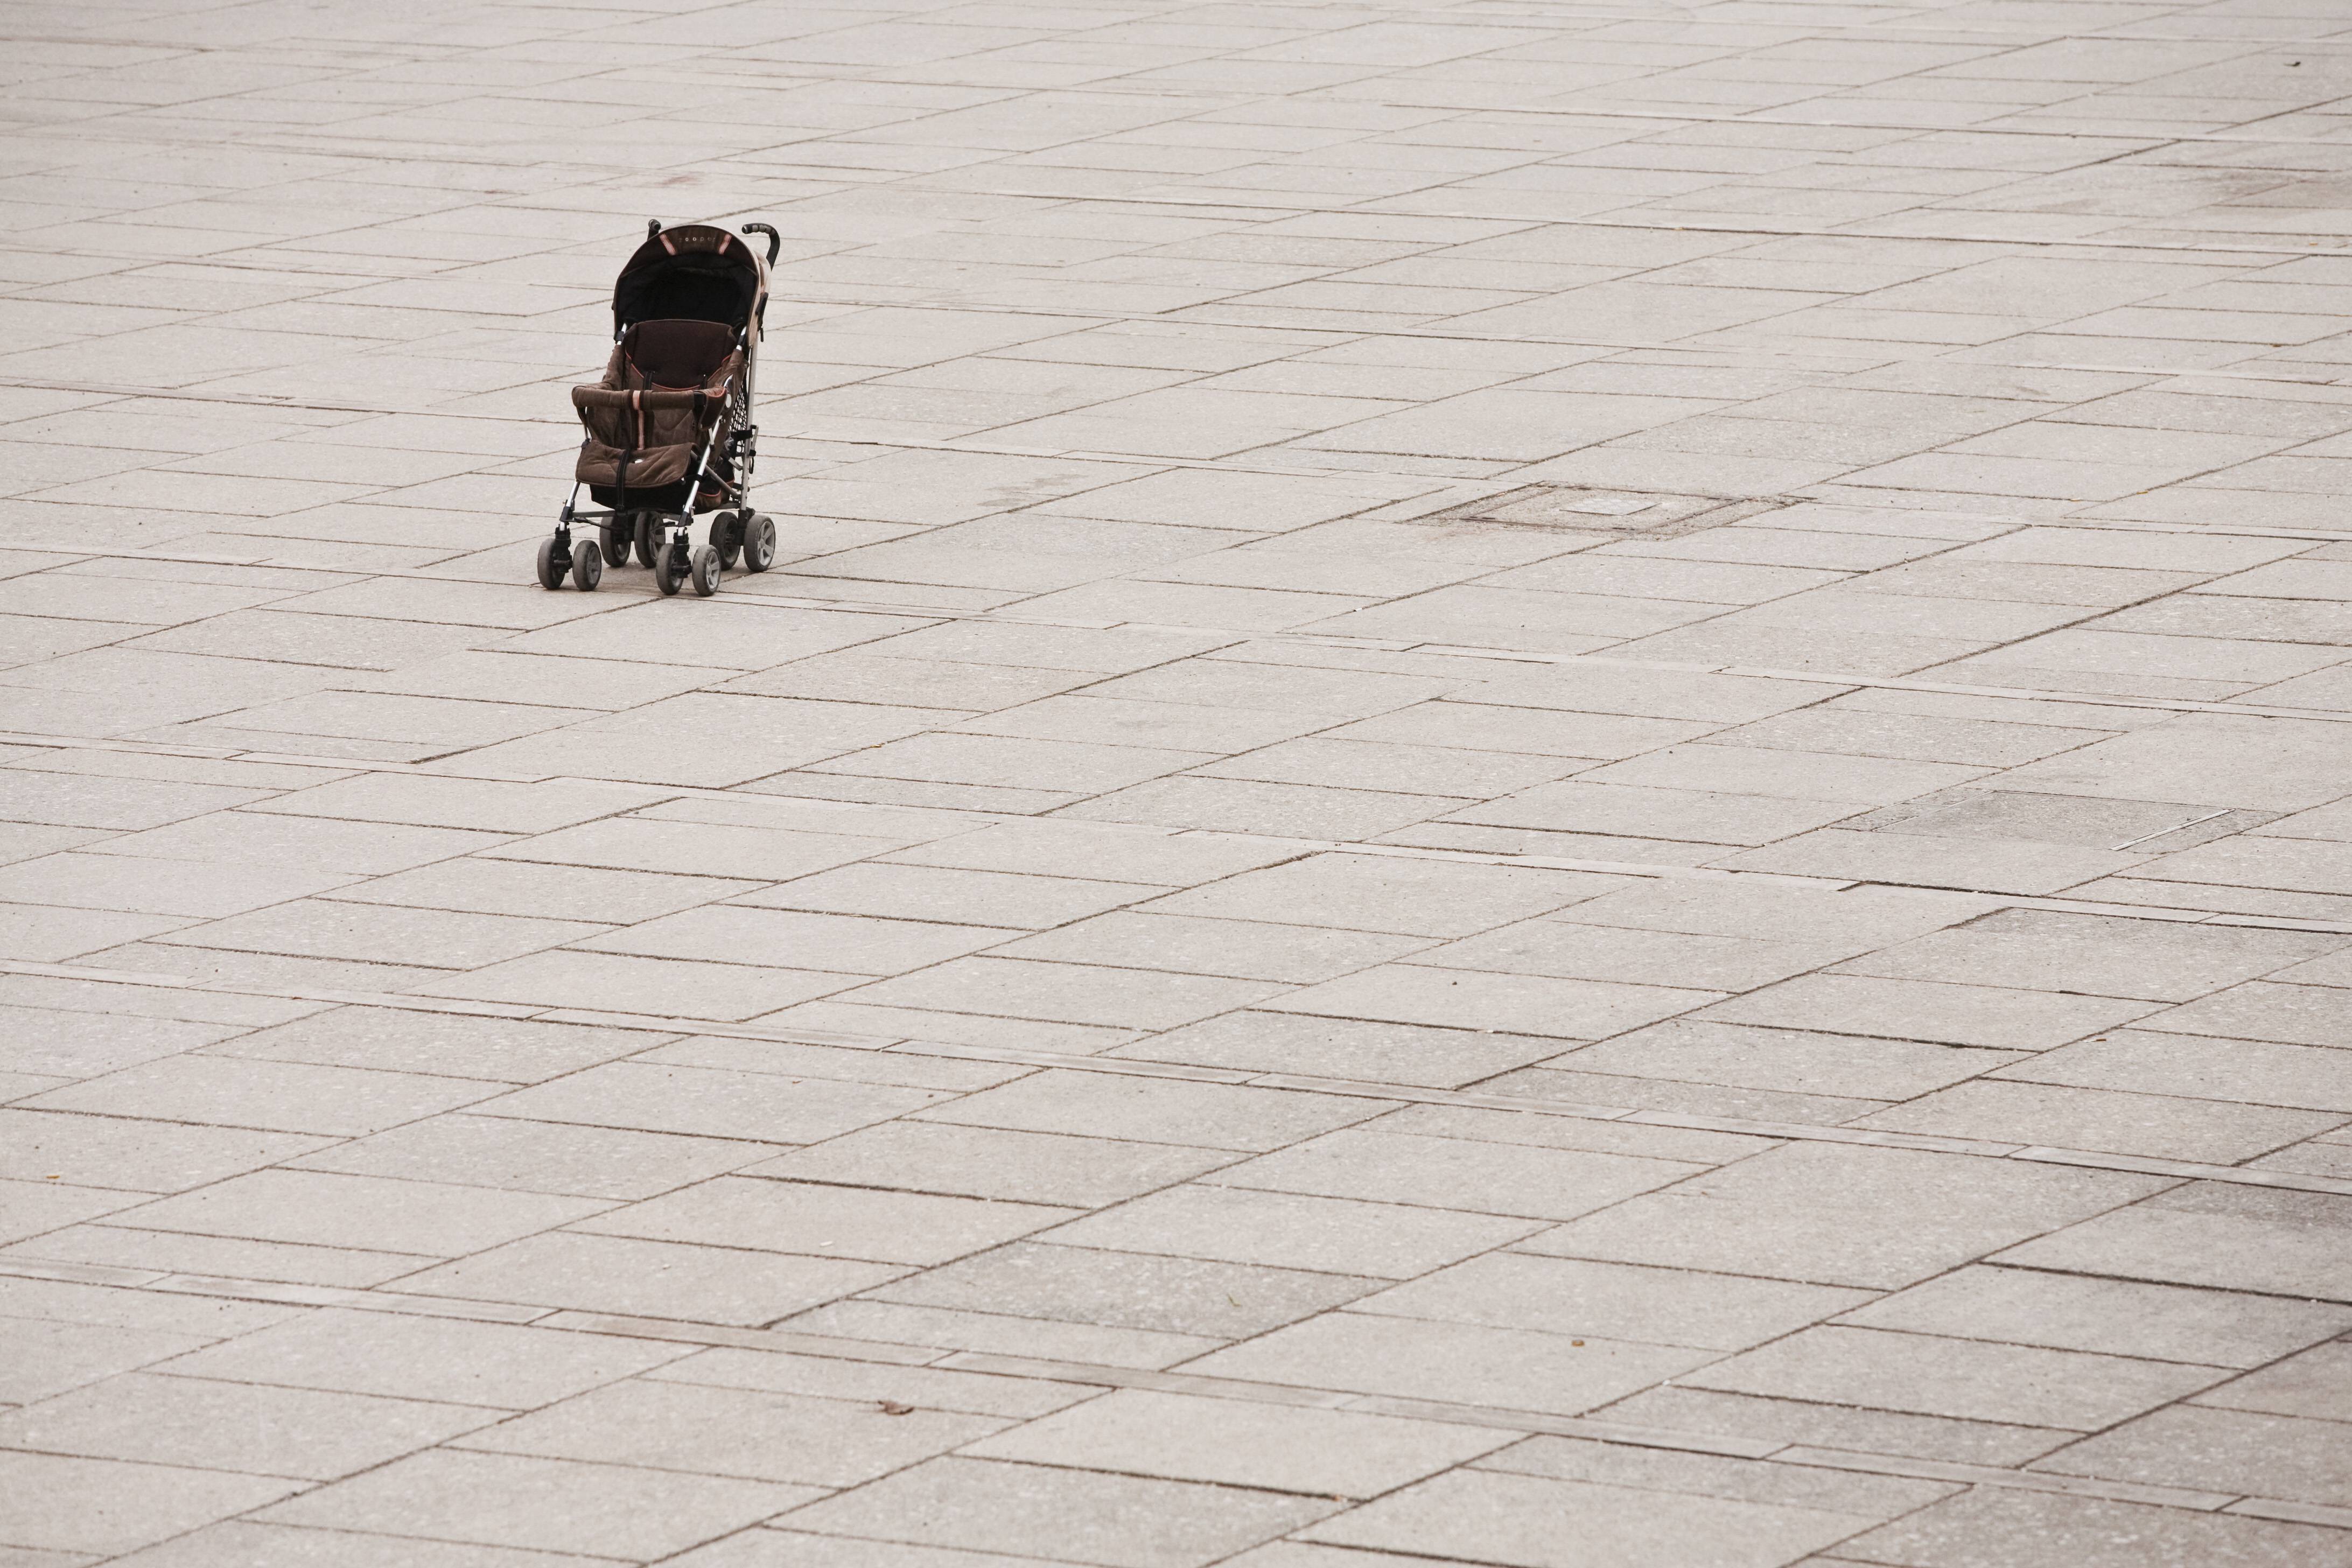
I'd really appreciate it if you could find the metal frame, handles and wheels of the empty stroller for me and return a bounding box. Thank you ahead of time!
[538,219,783,597]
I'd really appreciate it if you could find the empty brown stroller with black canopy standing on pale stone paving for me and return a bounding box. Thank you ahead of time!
[538,219,783,597]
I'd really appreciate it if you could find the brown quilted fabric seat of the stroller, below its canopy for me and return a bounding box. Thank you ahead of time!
[571,322,743,510]
